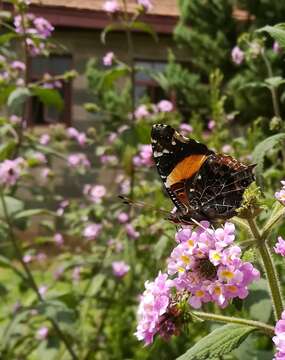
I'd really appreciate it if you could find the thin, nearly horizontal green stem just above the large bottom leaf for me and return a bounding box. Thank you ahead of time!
[191,311,274,337]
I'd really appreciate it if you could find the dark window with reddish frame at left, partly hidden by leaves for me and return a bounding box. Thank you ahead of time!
[27,55,72,125]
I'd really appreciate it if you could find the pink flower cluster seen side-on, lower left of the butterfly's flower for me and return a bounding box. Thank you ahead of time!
[135,273,176,345]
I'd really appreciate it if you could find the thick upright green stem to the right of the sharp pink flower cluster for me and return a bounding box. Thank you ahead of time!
[247,217,284,320]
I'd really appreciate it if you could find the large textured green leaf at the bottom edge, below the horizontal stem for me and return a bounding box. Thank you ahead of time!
[177,324,255,360]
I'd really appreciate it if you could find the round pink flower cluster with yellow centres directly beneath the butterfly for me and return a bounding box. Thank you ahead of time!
[168,222,260,308]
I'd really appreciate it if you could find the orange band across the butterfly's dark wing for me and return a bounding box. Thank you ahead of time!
[166,155,207,187]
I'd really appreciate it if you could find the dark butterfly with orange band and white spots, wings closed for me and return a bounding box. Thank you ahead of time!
[151,124,255,224]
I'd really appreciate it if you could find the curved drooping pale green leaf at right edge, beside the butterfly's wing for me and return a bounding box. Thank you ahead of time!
[252,133,285,186]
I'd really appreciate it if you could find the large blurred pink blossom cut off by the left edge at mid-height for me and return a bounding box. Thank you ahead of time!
[0,157,26,186]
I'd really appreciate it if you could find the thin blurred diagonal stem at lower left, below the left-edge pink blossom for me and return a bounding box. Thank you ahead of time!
[0,190,79,360]
